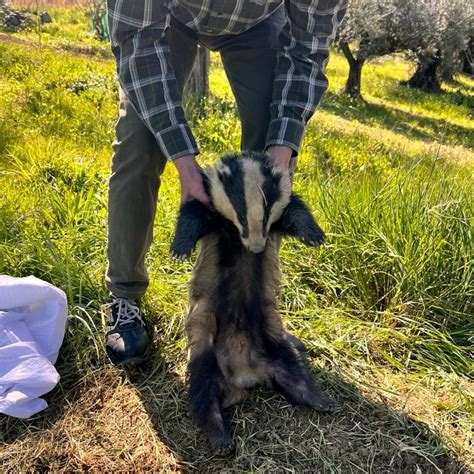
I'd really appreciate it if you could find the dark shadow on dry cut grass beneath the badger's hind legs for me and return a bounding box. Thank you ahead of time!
[132,358,462,473]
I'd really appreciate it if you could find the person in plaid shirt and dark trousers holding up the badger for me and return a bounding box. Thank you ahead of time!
[105,0,348,364]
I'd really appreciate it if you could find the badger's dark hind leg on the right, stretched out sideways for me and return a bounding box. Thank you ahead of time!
[269,335,336,412]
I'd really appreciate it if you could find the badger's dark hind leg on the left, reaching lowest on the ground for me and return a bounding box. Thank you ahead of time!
[186,305,234,456]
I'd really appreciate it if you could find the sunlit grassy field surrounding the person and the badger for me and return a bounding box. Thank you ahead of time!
[0,5,474,473]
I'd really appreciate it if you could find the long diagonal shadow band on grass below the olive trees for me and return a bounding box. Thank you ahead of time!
[324,93,474,147]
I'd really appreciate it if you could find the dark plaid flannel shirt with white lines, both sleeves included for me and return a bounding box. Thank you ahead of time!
[107,0,348,160]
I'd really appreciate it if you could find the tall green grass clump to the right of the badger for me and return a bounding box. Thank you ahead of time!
[286,161,474,375]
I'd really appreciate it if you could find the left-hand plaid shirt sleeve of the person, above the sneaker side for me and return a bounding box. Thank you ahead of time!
[107,0,199,160]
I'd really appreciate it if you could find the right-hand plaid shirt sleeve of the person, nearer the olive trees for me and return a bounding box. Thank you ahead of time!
[266,0,348,153]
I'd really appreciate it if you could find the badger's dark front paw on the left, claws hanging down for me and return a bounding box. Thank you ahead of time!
[170,199,209,260]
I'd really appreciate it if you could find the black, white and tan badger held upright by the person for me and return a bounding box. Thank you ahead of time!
[171,153,334,456]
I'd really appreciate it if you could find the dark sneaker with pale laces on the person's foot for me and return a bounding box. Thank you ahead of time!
[103,295,150,365]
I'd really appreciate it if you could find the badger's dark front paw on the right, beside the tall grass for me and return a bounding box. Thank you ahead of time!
[273,193,326,247]
